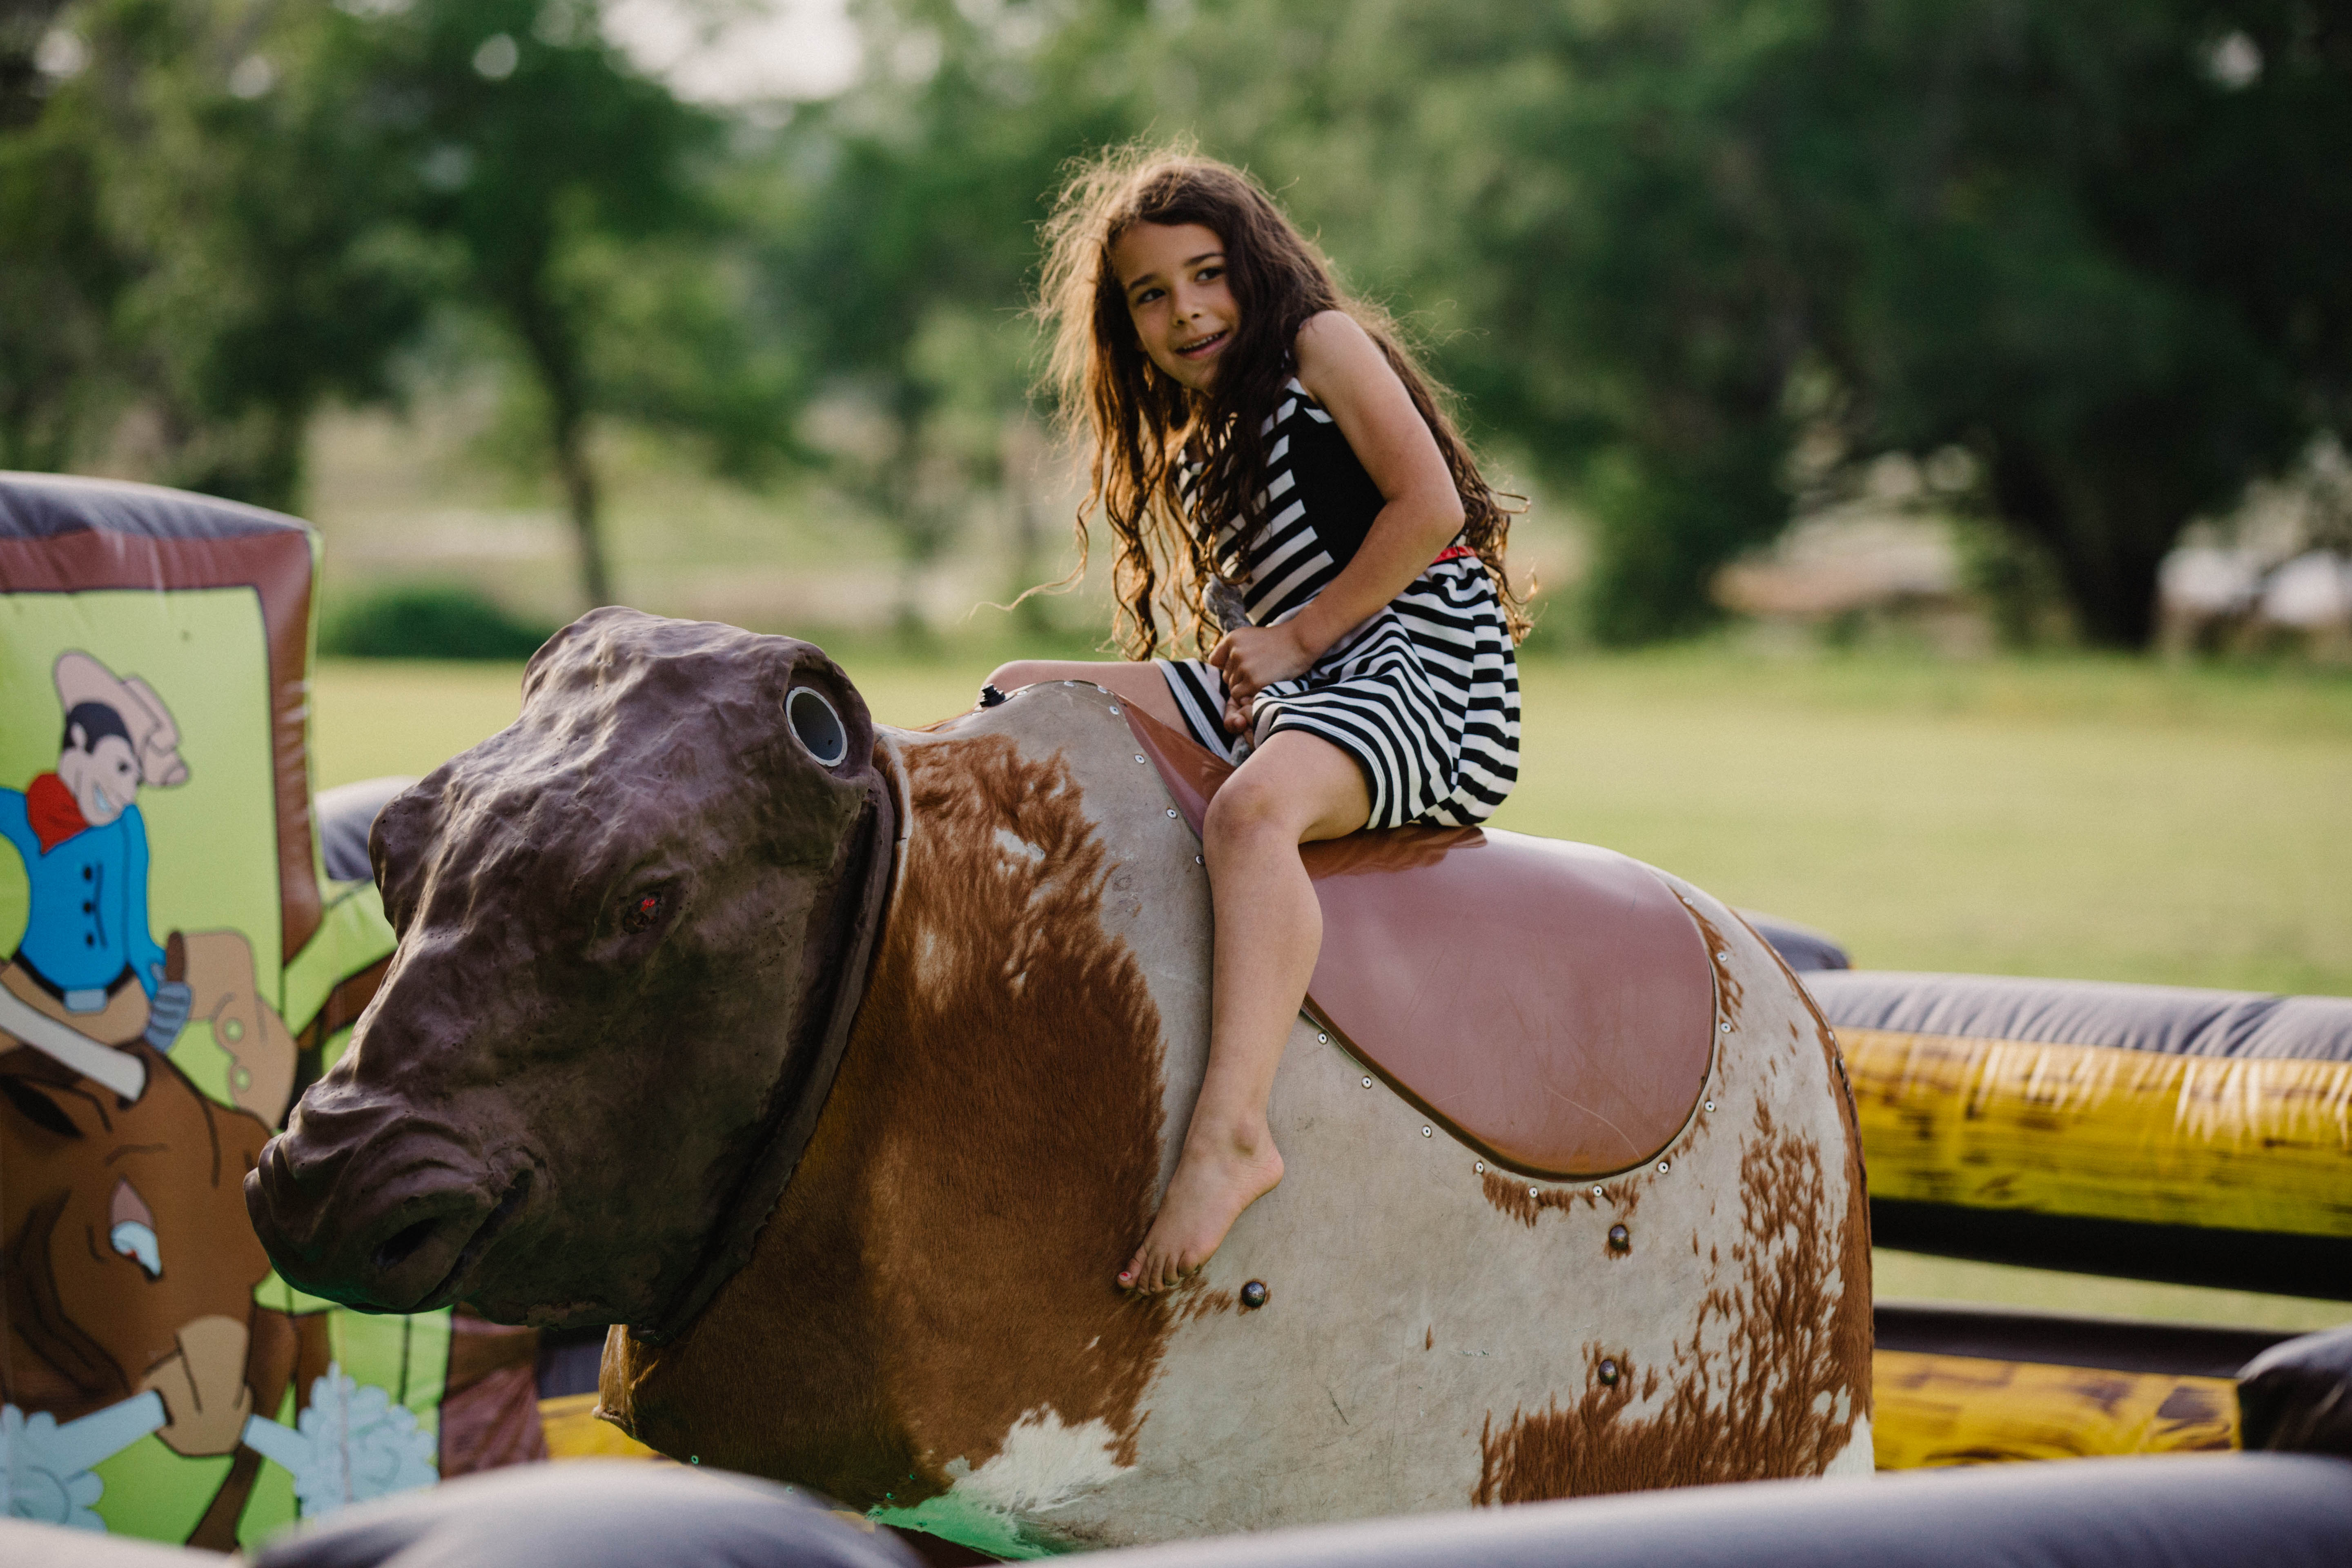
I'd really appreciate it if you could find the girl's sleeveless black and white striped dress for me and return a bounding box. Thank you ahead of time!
[1160,381,1519,828]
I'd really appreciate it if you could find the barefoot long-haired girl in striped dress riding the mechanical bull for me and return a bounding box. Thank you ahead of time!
[990,153,1526,1291]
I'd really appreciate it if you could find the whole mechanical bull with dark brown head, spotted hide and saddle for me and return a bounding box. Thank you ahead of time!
[247,611,1872,1552]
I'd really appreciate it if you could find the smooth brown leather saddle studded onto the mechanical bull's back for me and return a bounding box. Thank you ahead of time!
[1122,703,1715,1178]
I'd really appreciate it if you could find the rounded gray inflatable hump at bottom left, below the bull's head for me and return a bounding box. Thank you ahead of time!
[254,1460,920,1568]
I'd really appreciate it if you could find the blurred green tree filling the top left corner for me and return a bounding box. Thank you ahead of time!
[0,0,433,508]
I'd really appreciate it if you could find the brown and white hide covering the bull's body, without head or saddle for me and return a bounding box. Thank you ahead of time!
[602,684,1870,1552]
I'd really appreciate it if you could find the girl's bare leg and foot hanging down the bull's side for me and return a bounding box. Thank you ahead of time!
[1120,728,1371,1291]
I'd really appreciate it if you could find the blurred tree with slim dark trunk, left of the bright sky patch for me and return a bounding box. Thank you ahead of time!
[369,0,771,604]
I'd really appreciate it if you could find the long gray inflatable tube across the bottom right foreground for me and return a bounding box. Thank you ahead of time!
[1087,1455,2352,1568]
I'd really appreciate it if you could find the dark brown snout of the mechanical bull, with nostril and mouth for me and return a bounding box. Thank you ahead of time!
[245,1102,532,1312]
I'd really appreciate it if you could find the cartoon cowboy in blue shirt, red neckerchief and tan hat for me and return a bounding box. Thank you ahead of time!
[0,651,191,1081]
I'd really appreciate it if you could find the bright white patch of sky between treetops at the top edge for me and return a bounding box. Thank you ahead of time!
[604,0,858,103]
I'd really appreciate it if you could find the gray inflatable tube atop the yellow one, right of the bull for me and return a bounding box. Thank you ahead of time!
[1804,969,2352,1062]
